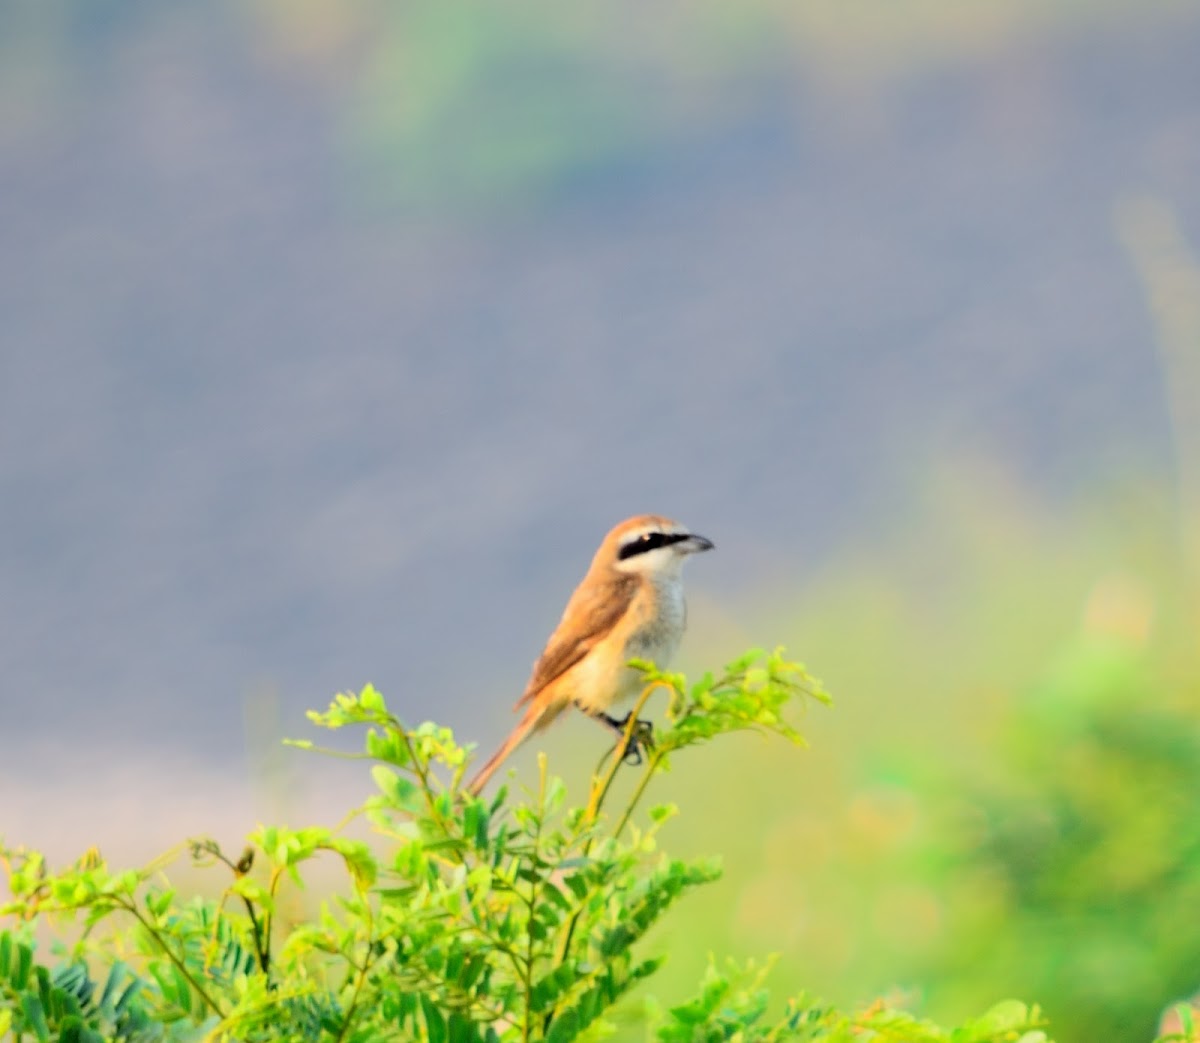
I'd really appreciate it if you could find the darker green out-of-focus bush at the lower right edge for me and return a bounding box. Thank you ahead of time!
[908,634,1200,1043]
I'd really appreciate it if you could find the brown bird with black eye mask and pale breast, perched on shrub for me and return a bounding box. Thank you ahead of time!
[467,514,713,796]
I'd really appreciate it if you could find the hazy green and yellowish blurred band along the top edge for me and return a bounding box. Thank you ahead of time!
[7,0,1188,212]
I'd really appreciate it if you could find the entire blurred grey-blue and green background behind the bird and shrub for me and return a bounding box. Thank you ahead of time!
[0,0,1200,1043]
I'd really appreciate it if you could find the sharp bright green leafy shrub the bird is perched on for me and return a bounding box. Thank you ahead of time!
[0,651,1046,1043]
